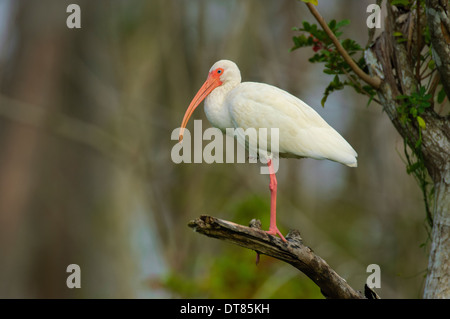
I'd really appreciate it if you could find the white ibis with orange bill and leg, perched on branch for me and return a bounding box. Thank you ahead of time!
[179,60,358,242]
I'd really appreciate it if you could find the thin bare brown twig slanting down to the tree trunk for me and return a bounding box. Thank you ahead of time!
[306,3,381,89]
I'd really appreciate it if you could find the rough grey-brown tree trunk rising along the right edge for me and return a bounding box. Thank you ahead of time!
[366,1,450,298]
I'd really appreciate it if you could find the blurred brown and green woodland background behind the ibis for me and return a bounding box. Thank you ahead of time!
[0,0,429,298]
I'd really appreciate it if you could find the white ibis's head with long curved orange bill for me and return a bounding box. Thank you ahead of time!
[179,60,241,142]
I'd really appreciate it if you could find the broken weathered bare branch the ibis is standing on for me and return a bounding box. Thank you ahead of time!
[188,215,370,299]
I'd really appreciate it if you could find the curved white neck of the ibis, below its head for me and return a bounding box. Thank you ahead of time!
[205,83,239,131]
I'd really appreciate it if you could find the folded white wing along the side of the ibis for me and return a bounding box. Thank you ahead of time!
[225,82,357,166]
